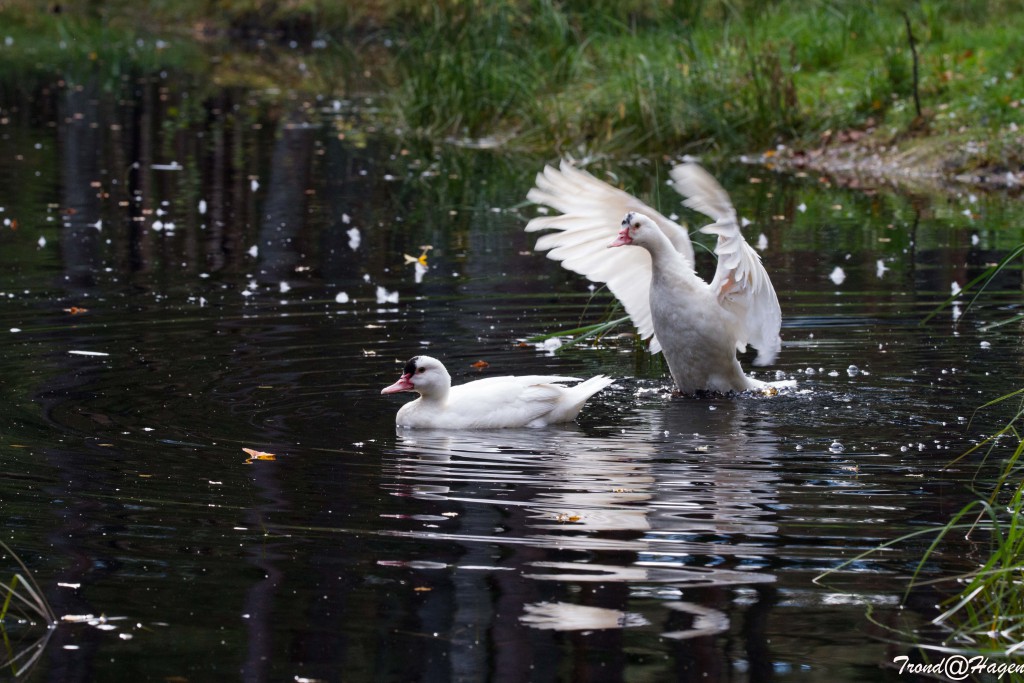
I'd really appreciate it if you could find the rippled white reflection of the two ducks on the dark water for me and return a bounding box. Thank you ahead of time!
[386,399,779,680]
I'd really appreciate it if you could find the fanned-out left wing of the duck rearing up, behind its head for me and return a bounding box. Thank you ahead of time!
[526,160,693,352]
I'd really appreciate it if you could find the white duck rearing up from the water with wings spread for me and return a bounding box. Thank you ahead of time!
[526,161,791,393]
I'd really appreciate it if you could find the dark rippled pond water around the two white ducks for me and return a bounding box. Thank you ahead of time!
[0,65,1024,682]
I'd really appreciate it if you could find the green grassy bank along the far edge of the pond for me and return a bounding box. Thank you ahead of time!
[6,0,1024,174]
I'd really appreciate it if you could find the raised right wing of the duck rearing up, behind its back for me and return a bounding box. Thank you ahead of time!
[671,164,782,366]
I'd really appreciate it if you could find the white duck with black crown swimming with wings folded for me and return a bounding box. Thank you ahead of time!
[381,355,614,429]
